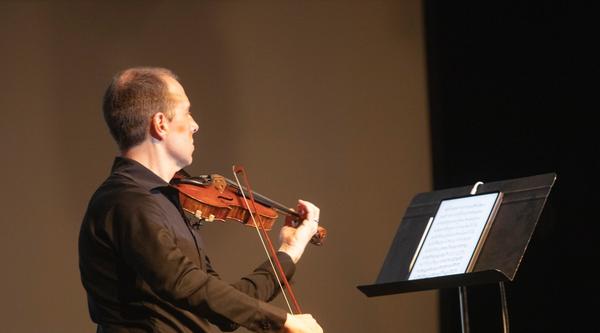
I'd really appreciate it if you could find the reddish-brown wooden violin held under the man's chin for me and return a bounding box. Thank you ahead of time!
[171,170,327,245]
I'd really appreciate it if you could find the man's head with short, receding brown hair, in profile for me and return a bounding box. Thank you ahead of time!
[103,67,198,164]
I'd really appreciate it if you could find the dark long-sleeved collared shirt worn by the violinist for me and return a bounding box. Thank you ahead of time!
[79,157,295,332]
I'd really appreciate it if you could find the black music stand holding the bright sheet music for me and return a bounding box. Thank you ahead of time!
[357,173,556,332]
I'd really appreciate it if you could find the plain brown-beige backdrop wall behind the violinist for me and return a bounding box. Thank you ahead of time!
[0,0,438,332]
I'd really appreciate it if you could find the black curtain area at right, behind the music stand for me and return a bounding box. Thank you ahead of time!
[424,0,600,333]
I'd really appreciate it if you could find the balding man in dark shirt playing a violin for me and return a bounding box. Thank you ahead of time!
[79,68,322,332]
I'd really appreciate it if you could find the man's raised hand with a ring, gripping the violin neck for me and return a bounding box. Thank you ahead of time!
[279,200,320,263]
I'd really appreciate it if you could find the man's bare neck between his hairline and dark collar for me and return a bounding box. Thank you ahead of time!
[121,142,181,183]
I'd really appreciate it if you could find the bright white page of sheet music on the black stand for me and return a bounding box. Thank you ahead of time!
[409,193,499,280]
